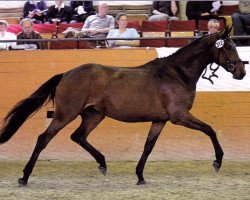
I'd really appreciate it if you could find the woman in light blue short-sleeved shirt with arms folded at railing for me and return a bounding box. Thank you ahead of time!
[107,13,140,47]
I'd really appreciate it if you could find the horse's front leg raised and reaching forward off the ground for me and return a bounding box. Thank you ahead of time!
[170,112,224,172]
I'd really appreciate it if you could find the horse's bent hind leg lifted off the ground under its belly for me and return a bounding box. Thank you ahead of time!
[71,108,107,175]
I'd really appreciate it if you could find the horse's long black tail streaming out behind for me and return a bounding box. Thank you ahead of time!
[0,74,63,144]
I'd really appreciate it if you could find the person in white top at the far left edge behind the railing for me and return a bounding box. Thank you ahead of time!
[0,20,16,50]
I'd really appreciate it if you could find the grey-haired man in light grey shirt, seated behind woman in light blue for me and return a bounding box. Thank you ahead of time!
[82,2,115,38]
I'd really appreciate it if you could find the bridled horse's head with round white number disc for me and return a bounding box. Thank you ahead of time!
[212,27,246,79]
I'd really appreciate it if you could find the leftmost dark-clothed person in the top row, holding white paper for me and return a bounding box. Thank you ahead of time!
[23,0,47,24]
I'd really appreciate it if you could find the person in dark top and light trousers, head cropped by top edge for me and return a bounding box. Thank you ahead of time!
[148,1,179,21]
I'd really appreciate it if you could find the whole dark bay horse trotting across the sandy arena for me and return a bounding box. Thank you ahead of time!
[0,28,246,185]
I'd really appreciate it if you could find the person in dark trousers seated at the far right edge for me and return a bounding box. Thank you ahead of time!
[232,1,250,35]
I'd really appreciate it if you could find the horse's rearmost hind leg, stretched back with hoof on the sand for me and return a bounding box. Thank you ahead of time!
[18,115,75,185]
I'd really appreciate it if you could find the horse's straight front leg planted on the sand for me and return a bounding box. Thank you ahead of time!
[136,121,166,185]
